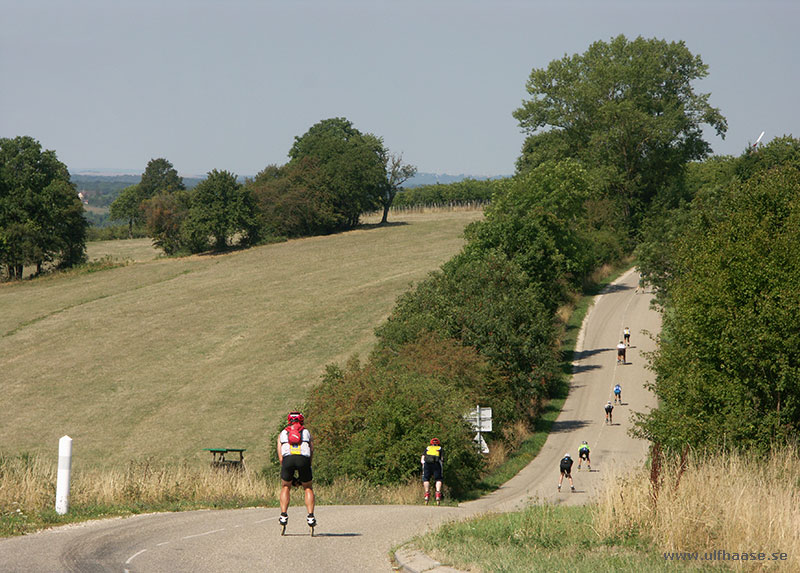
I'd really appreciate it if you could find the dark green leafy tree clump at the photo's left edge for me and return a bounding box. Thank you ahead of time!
[0,136,88,278]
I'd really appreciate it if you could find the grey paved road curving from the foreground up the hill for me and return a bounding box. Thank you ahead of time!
[0,272,659,573]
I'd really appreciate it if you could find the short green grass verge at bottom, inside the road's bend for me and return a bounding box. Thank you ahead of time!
[412,505,724,573]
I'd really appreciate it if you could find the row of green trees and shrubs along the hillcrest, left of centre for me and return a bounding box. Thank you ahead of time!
[111,118,416,254]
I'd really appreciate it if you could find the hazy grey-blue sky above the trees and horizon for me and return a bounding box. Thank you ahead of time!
[0,0,800,176]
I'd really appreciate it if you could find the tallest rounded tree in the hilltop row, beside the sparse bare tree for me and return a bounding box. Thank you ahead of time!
[289,117,386,228]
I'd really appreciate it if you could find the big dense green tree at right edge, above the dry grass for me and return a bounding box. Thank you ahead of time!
[637,147,800,451]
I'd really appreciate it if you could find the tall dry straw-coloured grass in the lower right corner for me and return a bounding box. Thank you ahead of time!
[594,447,800,571]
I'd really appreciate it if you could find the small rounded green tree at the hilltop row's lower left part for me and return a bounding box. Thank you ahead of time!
[185,169,252,252]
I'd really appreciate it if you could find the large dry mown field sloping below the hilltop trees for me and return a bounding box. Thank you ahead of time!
[0,211,481,469]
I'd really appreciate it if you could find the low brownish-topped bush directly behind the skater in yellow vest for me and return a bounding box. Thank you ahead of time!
[305,339,488,495]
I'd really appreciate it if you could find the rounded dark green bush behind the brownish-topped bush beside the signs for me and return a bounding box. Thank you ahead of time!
[376,253,558,421]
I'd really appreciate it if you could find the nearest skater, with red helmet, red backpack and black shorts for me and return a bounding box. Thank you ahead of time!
[278,412,317,528]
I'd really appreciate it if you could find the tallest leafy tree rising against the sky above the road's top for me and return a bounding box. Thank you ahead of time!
[514,35,727,231]
